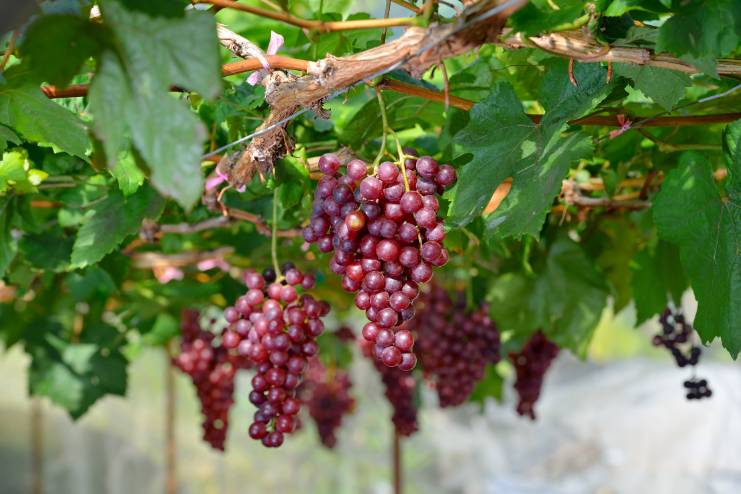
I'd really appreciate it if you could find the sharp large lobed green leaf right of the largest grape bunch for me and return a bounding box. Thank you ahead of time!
[450,61,613,237]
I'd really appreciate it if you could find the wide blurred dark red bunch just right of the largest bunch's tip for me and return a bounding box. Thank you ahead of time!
[405,285,500,407]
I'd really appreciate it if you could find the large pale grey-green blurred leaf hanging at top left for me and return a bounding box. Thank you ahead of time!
[90,0,221,208]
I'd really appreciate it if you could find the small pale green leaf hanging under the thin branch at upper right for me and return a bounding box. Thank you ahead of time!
[613,63,692,110]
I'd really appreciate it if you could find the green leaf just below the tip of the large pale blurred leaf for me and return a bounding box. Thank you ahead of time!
[72,187,163,268]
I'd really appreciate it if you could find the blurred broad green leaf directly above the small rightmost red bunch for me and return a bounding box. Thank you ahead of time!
[487,236,608,356]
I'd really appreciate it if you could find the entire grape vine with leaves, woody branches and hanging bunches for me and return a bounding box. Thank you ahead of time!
[0,0,741,474]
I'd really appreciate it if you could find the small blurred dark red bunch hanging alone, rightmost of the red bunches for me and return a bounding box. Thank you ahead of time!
[509,331,559,420]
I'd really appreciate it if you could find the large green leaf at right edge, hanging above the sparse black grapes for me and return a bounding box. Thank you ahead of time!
[653,145,741,358]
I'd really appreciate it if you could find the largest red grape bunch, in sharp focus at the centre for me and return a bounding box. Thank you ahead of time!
[303,151,456,371]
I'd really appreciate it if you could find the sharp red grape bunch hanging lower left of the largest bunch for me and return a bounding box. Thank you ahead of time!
[224,263,329,447]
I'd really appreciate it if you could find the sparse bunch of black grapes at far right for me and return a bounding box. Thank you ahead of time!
[652,307,713,400]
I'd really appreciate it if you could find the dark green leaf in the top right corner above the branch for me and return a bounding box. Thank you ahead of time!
[656,0,741,77]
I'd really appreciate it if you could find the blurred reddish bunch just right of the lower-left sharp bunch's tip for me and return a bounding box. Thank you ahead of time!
[302,359,355,449]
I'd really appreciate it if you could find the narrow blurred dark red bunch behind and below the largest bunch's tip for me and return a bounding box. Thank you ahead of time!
[359,338,419,436]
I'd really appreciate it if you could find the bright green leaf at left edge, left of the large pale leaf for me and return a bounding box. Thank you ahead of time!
[0,75,89,158]
